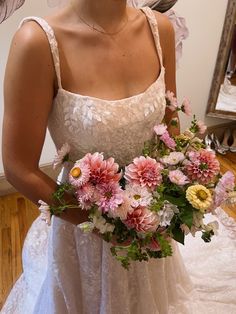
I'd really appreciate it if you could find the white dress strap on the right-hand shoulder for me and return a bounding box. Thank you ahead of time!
[141,7,163,67]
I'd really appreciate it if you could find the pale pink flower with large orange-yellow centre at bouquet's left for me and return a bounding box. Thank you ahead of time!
[69,162,90,188]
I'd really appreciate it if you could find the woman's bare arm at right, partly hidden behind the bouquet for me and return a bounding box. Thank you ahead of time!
[155,12,179,135]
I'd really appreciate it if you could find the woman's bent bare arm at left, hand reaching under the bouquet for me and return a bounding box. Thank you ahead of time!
[2,22,87,224]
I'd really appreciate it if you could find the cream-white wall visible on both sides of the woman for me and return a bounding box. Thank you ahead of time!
[0,0,231,173]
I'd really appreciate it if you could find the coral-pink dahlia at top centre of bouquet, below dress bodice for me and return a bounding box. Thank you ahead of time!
[125,156,163,189]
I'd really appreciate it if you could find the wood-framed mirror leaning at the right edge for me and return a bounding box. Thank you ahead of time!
[207,0,236,120]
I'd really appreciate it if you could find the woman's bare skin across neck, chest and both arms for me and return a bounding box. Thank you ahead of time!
[3,0,176,224]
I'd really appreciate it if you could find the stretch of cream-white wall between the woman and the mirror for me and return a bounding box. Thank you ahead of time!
[174,0,228,128]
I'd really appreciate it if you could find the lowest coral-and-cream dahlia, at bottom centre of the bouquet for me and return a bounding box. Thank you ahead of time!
[124,206,160,232]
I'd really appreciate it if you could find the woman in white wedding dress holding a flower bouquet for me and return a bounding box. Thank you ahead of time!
[2,0,235,314]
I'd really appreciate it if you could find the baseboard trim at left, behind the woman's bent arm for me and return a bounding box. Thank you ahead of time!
[0,164,58,196]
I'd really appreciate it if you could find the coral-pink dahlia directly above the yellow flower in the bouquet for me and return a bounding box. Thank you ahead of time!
[185,149,220,184]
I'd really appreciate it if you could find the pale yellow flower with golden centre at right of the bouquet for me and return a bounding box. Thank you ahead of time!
[186,184,212,212]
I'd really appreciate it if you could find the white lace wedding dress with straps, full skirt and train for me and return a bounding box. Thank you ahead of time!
[1,8,236,314]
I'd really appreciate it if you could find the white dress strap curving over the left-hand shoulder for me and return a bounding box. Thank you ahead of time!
[18,16,62,88]
